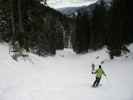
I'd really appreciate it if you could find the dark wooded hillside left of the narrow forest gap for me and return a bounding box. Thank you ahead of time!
[0,0,72,59]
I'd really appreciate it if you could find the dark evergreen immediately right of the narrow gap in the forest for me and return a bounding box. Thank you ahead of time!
[73,13,90,53]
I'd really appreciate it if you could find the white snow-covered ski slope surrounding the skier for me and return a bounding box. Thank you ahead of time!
[0,43,133,100]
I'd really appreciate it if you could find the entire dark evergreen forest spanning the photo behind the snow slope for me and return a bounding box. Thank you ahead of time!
[0,0,133,59]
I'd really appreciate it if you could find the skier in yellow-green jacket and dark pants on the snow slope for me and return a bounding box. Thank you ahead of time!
[92,65,106,87]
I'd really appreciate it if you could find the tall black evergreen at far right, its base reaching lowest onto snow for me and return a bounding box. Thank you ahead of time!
[109,0,131,58]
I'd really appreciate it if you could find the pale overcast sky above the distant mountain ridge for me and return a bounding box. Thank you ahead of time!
[47,0,96,9]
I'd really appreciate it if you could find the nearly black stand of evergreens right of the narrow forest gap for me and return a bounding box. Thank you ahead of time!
[73,0,133,58]
